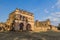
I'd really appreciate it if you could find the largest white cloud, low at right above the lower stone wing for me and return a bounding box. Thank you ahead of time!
[44,12,60,25]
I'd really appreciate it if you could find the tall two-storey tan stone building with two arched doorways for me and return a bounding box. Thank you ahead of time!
[6,9,34,31]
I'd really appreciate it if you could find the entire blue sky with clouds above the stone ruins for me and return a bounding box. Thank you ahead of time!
[0,0,60,25]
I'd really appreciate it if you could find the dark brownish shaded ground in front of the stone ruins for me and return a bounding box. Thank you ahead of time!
[0,31,60,40]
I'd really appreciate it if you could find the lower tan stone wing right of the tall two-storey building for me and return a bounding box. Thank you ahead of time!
[35,19,57,32]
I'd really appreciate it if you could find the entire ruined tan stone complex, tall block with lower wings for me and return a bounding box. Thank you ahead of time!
[0,9,57,32]
